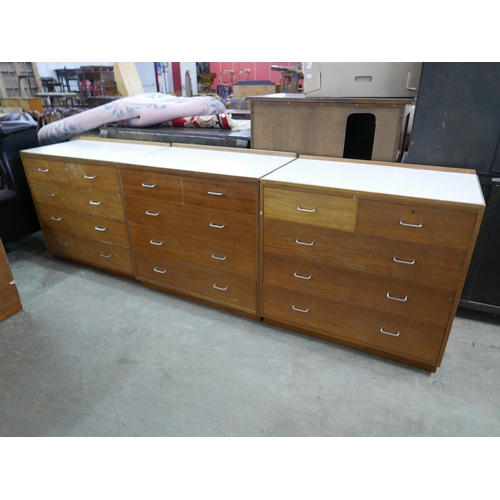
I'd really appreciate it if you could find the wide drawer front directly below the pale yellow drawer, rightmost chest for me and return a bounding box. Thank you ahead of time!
[264,219,465,289]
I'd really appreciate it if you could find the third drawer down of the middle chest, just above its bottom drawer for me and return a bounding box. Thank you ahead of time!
[130,223,257,280]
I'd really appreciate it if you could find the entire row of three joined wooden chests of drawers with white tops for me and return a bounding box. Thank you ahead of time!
[21,140,484,371]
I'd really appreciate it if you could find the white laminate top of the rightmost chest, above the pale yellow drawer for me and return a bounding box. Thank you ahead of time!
[263,158,484,206]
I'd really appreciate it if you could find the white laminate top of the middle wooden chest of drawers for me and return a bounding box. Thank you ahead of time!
[120,147,295,179]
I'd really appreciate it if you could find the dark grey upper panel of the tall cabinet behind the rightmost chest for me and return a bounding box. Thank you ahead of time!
[406,63,500,171]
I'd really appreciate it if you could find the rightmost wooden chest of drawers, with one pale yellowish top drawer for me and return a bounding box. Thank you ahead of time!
[261,157,484,371]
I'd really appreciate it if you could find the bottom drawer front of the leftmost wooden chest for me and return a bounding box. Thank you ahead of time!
[43,229,134,276]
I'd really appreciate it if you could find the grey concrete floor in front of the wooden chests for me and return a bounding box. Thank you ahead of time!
[0,233,500,437]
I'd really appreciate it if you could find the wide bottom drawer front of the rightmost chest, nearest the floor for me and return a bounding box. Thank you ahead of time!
[263,285,445,363]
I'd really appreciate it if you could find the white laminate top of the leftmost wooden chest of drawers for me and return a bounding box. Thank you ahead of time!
[24,139,170,162]
